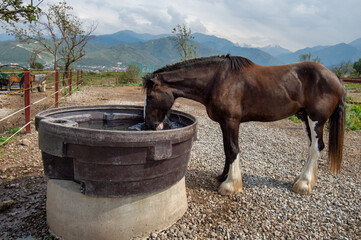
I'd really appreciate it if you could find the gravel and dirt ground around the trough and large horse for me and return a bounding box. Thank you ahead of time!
[0,88,361,239]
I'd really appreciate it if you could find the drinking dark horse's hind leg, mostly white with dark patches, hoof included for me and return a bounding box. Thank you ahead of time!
[292,117,325,194]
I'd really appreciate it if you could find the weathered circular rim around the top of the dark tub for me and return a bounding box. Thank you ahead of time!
[35,105,198,147]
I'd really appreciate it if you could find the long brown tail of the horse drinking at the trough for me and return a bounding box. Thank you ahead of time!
[328,87,346,174]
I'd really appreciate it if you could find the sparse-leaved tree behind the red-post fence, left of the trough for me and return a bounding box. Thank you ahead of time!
[6,1,96,85]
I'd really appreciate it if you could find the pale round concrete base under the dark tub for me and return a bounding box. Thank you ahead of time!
[46,177,187,240]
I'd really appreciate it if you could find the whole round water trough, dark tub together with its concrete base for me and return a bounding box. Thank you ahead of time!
[35,105,197,239]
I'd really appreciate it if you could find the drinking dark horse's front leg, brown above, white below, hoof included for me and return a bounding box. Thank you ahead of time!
[218,119,242,195]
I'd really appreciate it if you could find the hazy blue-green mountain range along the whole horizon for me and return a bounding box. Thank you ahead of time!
[0,30,361,67]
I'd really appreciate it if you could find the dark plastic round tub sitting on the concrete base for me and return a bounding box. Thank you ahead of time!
[35,105,197,197]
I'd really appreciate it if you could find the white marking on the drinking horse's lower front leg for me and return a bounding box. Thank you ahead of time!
[219,154,242,195]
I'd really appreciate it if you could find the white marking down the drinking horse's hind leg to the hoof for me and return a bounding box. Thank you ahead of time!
[294,117,320,193]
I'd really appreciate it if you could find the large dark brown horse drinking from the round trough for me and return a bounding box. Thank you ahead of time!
[143,55,346,195]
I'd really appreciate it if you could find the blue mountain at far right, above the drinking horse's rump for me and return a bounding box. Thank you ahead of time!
[278,43,361,68]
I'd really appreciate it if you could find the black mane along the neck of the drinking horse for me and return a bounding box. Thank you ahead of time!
[143,54,254,88]
